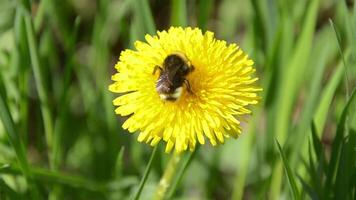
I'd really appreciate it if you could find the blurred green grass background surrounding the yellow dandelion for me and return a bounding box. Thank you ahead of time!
[0,0,356,200]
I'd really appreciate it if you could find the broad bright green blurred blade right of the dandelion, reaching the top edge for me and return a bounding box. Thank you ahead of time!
[270,0,319,199]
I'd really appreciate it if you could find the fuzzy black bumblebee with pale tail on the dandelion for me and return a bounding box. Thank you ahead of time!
[153,52,194,101]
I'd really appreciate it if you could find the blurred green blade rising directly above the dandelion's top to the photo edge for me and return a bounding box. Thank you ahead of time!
[171,0,188,27]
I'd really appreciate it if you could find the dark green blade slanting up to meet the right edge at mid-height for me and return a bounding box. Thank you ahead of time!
[325,89,356,195]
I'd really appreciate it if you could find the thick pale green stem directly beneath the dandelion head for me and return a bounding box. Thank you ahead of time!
[154,152,182,200]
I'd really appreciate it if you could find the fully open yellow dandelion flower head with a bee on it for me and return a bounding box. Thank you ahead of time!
[109,27,261,152]
